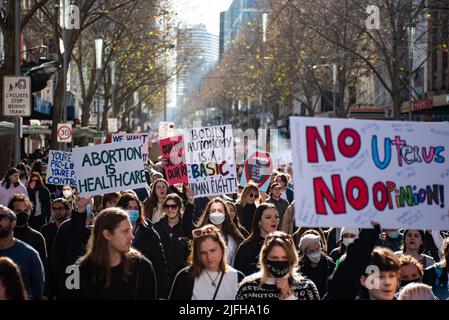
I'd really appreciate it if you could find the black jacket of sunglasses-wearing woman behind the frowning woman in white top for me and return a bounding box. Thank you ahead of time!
[154,216,190,283]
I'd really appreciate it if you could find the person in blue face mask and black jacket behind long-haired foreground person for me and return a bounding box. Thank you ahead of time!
[117,191,170,299]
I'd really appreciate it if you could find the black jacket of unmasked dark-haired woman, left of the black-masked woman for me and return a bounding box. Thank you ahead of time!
[234,238,264,276]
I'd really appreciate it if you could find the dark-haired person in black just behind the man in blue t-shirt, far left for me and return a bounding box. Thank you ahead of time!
[8,194,48,292]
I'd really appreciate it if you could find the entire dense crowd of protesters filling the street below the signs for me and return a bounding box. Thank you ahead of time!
[0,150,449,300]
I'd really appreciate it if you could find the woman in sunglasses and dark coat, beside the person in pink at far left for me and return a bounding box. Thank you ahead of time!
[27,172,51,230]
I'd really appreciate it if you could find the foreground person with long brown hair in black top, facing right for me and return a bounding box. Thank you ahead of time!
[77,208,156,300]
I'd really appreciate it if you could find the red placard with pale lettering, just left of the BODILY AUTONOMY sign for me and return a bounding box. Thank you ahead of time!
[159,135,188,185]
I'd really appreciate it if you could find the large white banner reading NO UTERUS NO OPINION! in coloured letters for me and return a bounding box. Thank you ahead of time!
[290,117,449,230]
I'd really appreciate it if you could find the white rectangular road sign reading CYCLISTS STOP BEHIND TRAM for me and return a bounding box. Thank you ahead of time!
[3,76,31,117]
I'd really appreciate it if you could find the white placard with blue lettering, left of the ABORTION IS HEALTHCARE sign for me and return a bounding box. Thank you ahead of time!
[45,150,76,187]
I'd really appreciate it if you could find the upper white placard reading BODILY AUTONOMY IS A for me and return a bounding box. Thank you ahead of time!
[184,125,235,164]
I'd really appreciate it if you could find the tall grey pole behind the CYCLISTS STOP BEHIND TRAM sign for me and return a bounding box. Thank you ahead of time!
[14,0,22,166]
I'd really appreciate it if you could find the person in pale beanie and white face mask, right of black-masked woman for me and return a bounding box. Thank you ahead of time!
[298,230,335,297]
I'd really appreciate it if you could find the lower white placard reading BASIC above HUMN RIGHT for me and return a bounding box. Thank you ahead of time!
[187,162,238,198]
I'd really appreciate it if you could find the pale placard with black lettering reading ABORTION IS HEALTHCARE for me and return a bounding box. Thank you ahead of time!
[72,140,146,196]
